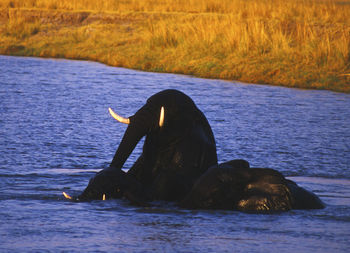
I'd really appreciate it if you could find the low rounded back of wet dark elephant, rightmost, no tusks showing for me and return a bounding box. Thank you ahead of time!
[180,159,324,212]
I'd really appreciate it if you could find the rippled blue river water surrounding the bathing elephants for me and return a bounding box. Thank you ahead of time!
[0,56,350,252]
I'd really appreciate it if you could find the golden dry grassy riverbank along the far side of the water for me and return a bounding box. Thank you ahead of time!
[0,0,350,92]
